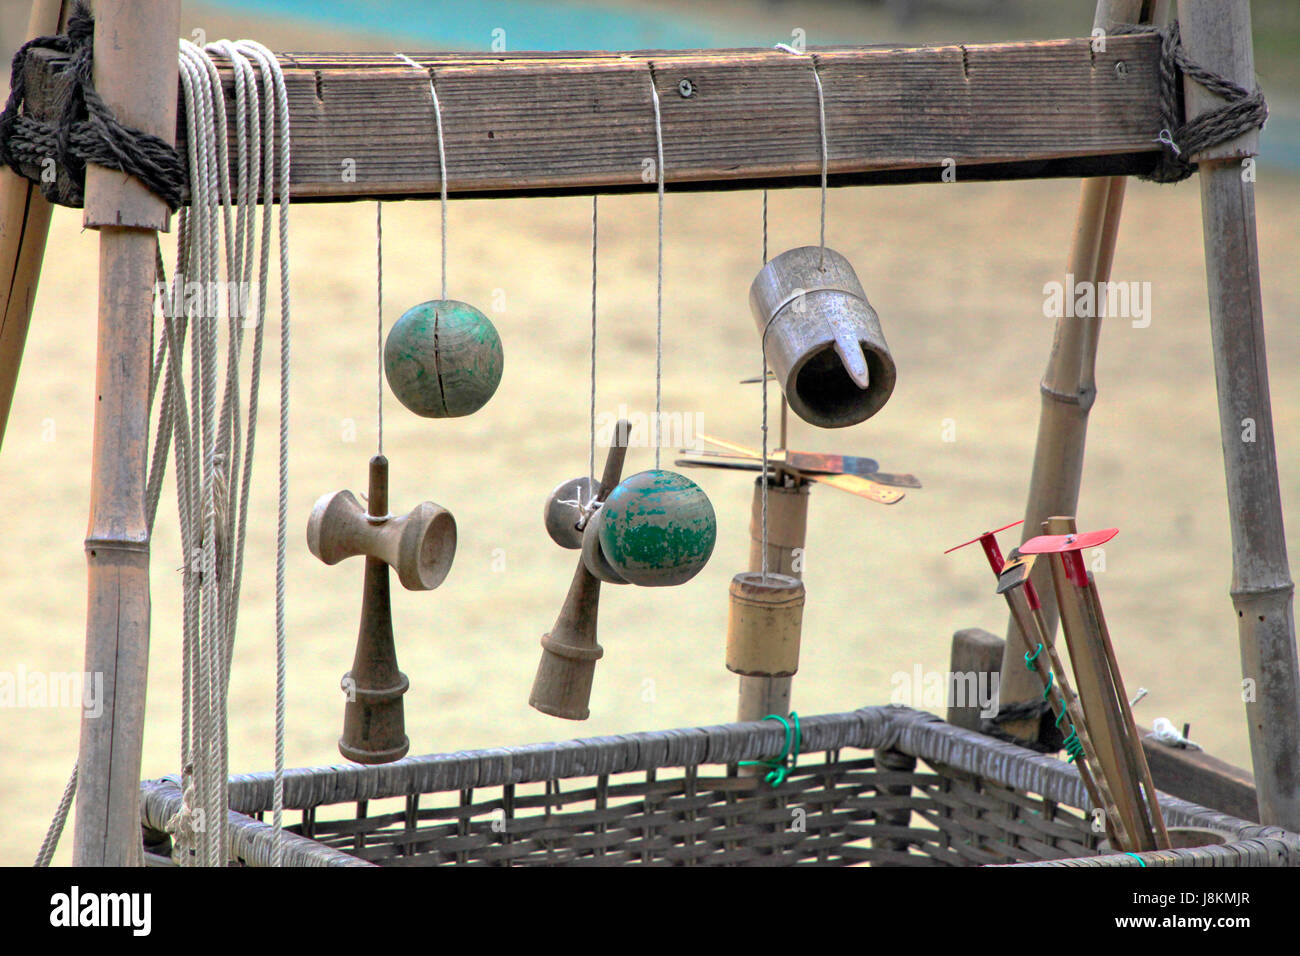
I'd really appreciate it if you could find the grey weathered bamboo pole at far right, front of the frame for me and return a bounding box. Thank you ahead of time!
[1178,0,1300,830]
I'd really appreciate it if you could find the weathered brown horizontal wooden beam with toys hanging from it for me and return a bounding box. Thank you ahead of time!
[22,35,1161,202]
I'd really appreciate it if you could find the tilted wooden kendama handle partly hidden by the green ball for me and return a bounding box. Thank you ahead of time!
[528,420,631,721]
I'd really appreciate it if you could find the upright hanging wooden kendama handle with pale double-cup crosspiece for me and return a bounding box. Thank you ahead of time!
[307,455,456,763]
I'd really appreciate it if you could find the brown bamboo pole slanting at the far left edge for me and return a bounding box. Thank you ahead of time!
[0,0,64,447]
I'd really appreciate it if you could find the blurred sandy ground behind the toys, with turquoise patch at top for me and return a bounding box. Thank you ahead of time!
[0,0,1300,864]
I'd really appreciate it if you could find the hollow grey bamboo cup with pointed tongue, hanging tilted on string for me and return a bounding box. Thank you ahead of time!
[749,246,897,428]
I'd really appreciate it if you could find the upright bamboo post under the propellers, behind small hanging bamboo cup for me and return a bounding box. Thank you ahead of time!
[736,473,811,721]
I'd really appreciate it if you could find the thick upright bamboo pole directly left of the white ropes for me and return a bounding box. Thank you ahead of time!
[73,0,181,866]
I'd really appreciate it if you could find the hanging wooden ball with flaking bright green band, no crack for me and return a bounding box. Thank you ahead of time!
[599,470,718,588]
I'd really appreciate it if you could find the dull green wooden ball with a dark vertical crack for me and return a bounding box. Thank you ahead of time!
[384,299,506,419]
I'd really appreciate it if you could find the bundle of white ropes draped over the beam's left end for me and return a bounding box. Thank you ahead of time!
[151,40,289,866]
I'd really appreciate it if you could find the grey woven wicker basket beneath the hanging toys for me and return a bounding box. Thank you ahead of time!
[142,706,1300,866]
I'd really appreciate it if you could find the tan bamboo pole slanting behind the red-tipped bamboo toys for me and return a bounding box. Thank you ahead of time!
[1001,0,1169,736]
